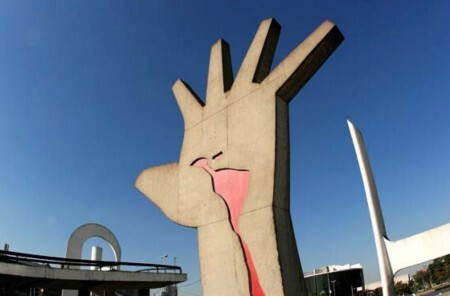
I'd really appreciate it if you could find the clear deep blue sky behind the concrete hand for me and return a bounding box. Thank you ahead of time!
[0,0,450,296]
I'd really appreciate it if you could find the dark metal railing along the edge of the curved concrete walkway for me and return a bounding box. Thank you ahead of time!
[0,250,183,273]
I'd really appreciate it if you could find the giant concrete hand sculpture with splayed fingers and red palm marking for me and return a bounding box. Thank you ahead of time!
[136,19,343,296]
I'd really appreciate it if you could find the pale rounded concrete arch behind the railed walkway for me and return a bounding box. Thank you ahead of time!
[66,223,122,268]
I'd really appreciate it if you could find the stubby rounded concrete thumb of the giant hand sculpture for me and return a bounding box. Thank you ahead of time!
[134,162,178,222]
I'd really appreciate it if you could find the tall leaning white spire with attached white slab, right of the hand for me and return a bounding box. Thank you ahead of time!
[347,120,450,296]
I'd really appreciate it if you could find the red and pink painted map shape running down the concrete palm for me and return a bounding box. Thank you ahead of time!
[192,158,264,296]
